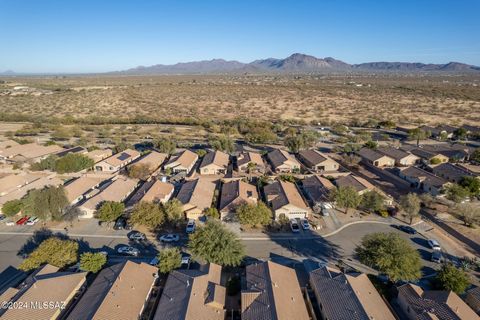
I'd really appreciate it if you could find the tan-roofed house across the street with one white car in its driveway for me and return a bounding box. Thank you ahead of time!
[177,178,216,219]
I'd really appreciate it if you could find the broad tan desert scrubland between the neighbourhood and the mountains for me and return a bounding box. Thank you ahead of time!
[0,75,480,125]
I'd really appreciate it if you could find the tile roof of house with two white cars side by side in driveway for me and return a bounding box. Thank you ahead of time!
[264,181,309,210]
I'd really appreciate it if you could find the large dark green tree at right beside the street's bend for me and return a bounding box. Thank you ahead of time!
[355,232,422,282]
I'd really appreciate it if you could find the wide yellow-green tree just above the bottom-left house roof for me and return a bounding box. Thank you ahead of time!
[18,237,78,271]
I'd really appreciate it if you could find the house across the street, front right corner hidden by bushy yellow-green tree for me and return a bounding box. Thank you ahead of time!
[219,180,258,221]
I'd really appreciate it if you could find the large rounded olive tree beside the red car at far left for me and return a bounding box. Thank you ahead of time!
[22,186,69,221]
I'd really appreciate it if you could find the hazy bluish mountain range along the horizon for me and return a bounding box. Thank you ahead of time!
[116,53,480,75]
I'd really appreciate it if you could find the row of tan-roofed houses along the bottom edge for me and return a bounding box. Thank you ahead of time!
[0,260,479,320]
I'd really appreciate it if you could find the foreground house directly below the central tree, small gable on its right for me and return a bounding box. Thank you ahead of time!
[153,263,226,320]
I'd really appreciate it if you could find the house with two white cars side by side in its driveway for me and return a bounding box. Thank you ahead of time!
[263,181,310,220]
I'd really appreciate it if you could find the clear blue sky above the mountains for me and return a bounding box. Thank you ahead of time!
[0,0,480,72]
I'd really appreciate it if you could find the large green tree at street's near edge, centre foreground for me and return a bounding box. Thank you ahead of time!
[188,220,245,266]
